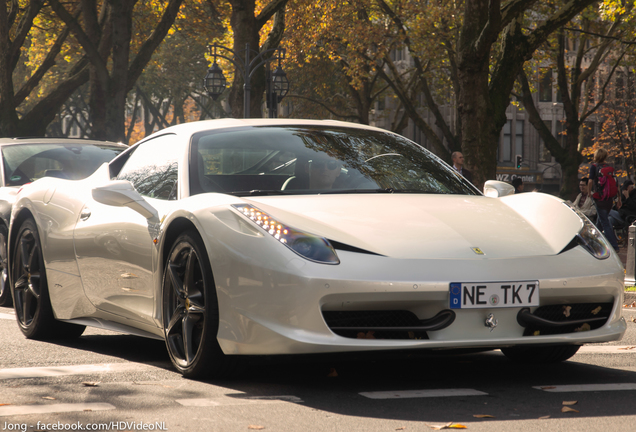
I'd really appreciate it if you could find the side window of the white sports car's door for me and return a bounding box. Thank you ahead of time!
[117,134,181,200]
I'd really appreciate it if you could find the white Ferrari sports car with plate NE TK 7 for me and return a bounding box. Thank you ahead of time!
[9,119,626,377]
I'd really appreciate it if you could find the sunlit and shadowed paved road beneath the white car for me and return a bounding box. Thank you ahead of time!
[0,308,636,432]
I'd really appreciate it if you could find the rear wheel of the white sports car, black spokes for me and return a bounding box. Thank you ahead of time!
[11,219,86,340]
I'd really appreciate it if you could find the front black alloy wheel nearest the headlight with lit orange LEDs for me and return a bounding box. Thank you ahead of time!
[163,231,232,378]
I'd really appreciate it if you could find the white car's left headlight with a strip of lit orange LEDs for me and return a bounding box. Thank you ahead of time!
[232,204,340,264]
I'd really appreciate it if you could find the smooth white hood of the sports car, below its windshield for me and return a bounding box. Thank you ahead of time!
[246,193,583,259]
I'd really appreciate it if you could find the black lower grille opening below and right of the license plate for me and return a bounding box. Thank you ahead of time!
[523,303,614,336]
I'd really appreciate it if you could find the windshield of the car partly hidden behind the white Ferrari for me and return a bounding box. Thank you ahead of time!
[2,142,125,186]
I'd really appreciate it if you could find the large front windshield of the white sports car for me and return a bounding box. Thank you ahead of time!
[190,126,479,196]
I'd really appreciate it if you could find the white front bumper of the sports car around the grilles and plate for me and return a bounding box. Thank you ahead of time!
[209,228,626,355]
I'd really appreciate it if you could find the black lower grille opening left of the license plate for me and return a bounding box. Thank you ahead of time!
[322,310,428,339]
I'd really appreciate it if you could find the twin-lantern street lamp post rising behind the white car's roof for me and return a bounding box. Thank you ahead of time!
[203,43,289,118]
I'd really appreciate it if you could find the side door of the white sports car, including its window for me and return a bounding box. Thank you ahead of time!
[74,134,180,325]
